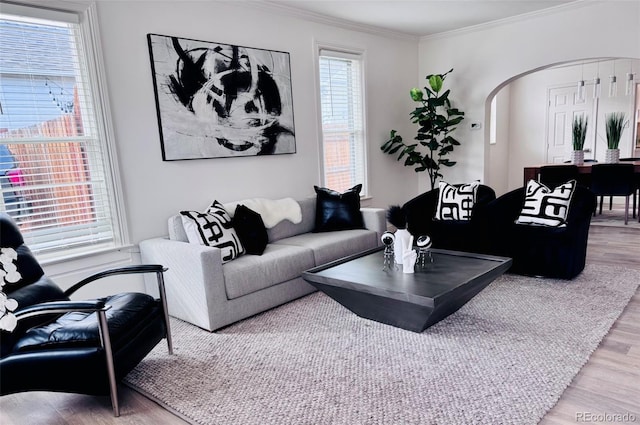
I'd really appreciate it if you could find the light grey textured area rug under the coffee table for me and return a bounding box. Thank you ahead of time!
[125,266,640,425]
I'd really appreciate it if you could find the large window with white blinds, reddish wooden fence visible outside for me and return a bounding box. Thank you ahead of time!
[0,4,123,259]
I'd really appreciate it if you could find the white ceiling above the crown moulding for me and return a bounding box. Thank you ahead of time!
[266,0,582,37]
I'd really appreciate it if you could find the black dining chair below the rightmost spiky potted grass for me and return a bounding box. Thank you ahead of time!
[590,163,636,224]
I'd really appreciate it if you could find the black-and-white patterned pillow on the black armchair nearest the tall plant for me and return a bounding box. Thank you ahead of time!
[434,182,480,221]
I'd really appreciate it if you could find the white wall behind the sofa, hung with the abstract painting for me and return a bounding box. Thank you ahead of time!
[41,0,418,289]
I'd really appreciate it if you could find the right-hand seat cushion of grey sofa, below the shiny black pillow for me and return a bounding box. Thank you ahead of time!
[274,229,378,266]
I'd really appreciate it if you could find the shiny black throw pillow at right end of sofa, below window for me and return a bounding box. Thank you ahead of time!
[313,184,364,232]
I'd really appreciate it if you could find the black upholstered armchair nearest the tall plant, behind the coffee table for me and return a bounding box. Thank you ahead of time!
[402,184,496,252]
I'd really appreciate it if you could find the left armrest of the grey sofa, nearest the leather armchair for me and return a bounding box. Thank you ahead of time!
[140,238,227,329]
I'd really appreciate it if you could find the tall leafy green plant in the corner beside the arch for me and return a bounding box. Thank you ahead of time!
[380,69,464,189]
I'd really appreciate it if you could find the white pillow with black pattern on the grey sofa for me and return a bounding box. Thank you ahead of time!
[180,201,244,263]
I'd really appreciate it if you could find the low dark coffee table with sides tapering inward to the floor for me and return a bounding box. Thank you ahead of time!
[302,248,512,332]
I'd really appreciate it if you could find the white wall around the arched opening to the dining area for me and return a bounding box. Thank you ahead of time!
[419,0,640,192]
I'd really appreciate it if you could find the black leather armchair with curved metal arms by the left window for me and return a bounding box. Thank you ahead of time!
[0,213,173,416]
